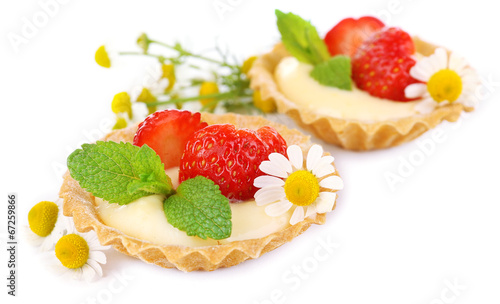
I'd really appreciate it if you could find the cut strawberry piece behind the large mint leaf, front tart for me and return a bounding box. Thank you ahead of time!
[134,109,208,169]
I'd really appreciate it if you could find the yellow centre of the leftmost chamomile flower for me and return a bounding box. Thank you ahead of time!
[28,201,59,237]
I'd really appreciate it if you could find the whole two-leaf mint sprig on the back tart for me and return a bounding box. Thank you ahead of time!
[276,10,352,90]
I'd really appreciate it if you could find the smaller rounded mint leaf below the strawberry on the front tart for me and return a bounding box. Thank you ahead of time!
[163,176,232,240]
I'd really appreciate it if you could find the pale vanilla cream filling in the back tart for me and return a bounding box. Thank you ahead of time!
[274,57,421,122]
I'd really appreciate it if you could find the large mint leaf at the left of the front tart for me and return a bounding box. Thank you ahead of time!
[68,141,174,205]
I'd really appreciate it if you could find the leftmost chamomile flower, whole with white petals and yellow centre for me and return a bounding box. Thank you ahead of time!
[24,201,71,251]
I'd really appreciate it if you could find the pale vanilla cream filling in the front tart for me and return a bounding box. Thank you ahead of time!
[95,168,292,247]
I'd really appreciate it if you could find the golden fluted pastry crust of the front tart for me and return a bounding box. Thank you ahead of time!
[59,113,337,271]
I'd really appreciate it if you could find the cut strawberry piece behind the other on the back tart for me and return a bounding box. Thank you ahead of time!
[324,16,384,57]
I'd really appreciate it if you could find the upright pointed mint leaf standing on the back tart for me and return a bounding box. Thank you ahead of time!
[276,10,330,65]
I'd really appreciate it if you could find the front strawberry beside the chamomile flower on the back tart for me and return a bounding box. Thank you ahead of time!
[352,28,419,101]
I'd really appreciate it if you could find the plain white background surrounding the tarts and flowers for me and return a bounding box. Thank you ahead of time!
[0,0,500,303]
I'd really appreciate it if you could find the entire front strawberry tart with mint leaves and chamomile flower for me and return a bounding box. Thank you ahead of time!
[60,110,343,271]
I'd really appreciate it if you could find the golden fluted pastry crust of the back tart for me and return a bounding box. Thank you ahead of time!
[249,37,473,150]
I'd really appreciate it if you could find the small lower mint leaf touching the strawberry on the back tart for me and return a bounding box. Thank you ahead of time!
[311,55,352,91]
